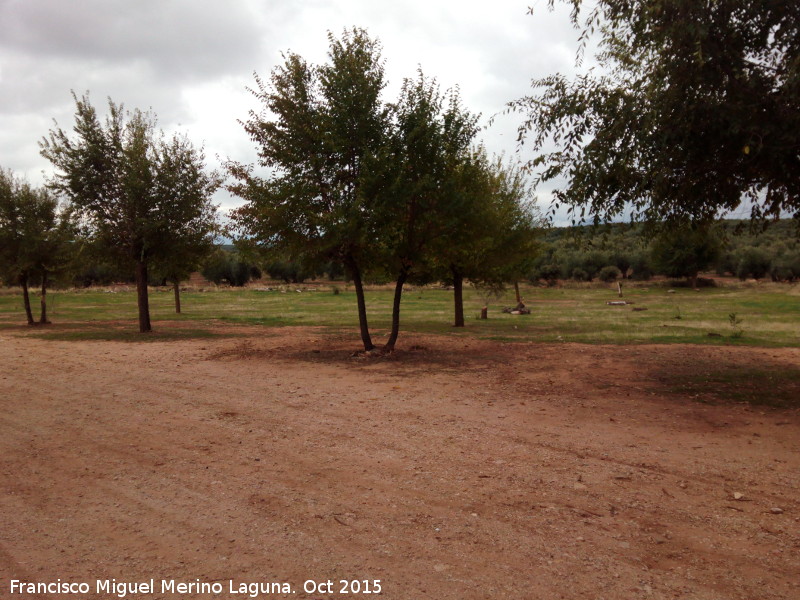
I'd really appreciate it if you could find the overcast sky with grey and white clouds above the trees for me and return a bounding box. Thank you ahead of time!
[0,0,578,216]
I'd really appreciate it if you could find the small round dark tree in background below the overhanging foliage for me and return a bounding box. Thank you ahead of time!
[650,226,721,289]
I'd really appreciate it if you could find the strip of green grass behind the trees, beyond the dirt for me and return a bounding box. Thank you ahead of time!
[0,284,800,346]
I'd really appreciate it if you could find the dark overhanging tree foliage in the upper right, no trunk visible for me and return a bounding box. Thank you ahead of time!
[511,0,800,225]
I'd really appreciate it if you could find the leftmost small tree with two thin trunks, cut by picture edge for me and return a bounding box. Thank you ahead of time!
[0,169,76,325]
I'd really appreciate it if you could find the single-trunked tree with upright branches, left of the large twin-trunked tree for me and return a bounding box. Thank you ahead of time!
[40,94,221,333]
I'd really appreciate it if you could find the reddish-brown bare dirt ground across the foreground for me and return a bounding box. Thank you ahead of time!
[0,324,800,600]
